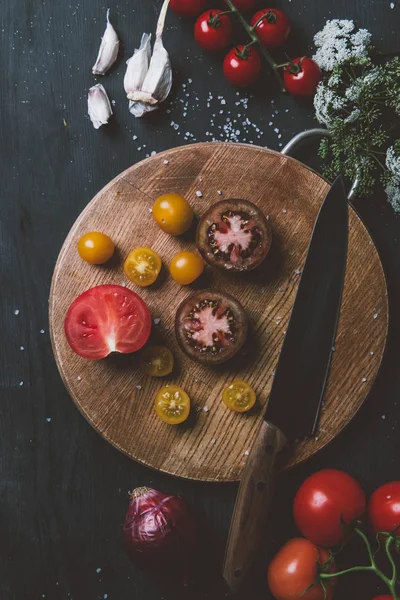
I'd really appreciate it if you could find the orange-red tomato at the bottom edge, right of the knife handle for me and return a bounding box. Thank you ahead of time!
[268,538,336,600]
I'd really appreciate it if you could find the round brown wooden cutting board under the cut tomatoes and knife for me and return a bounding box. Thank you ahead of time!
[50,143,388,481]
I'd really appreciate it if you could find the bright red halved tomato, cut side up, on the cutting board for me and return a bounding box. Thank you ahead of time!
[65,285,151,360]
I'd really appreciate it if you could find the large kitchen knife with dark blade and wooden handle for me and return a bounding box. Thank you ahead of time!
[223,177,348,592]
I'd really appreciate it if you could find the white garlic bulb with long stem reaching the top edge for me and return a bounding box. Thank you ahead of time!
[124,0,172,117]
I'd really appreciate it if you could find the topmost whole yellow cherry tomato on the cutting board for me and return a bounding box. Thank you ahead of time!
[153,194,194,235]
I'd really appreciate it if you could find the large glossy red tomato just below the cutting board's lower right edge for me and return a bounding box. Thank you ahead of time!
[293,469,366,547]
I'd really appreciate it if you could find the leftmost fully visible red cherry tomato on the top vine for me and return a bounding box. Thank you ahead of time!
[194,8,233,52]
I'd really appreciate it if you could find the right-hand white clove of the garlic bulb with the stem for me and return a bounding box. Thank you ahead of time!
[139,37,172,104]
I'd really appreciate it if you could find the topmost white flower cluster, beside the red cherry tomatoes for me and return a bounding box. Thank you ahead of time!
[313,19,371,71]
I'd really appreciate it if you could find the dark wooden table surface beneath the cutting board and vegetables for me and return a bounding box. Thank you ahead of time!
[0,0,400,600]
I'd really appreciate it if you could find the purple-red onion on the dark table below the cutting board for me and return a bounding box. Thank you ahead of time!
[123,487,196,577]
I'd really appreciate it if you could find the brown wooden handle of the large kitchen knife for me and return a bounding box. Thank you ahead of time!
[222,421,287,592]
